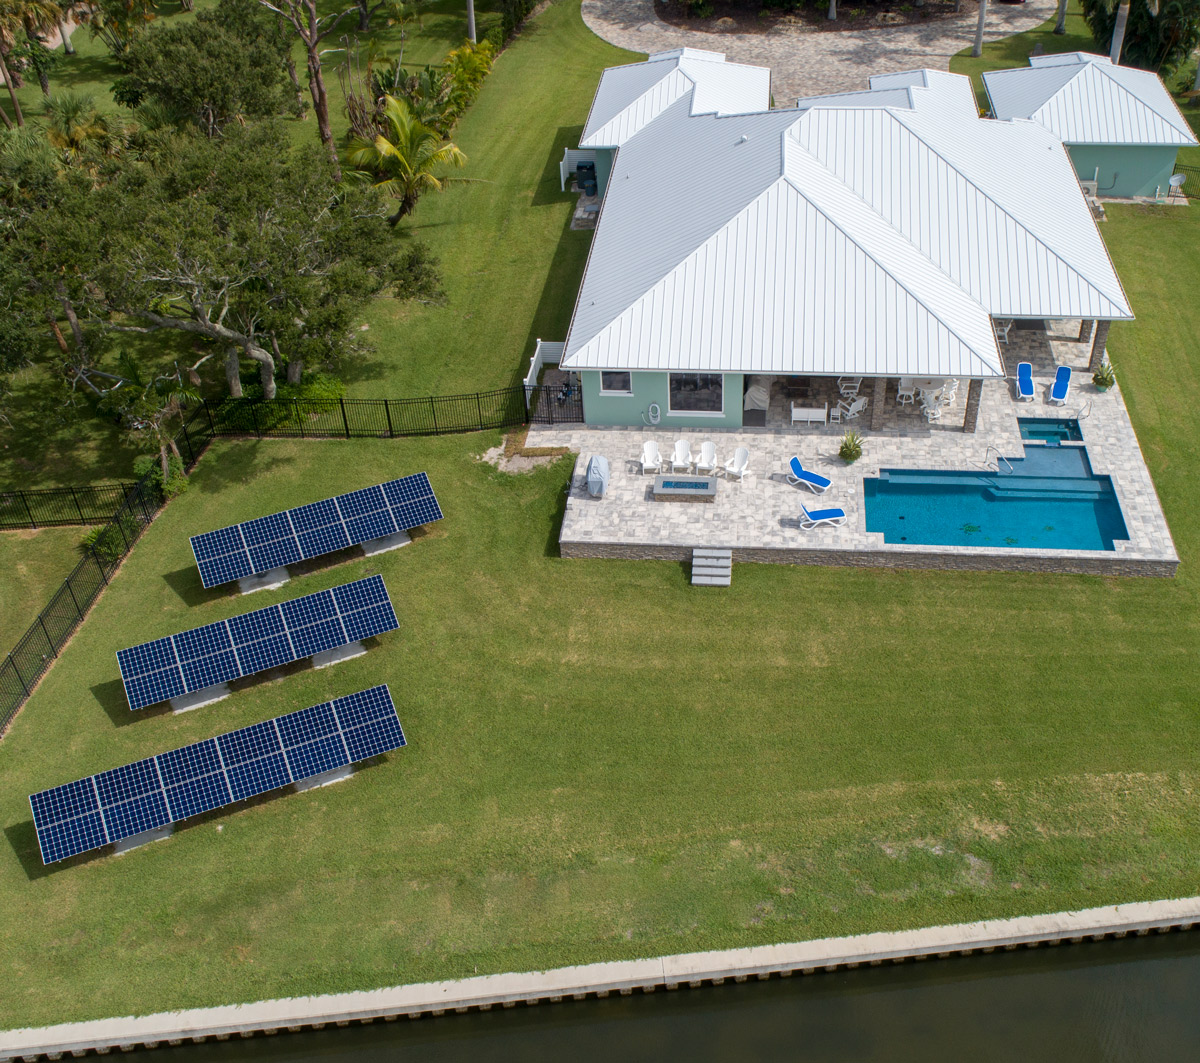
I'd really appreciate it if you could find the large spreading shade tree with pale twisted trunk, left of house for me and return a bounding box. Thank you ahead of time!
[0,121,438,398]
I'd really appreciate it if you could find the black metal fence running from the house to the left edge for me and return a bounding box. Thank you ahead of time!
[0,384,583,733]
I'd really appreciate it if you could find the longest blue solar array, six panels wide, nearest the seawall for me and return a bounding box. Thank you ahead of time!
[29,686,404,864]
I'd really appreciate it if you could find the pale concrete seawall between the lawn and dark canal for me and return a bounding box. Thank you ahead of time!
[0,897,1200,1061]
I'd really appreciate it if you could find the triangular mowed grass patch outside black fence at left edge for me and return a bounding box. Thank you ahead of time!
[0,528,88,654]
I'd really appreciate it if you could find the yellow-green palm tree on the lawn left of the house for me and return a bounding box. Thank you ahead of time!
[346,96,467,226]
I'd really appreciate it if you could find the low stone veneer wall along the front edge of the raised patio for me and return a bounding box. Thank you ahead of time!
[559,542,1178,577]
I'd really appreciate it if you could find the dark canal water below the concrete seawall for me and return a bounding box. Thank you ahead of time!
[139,931,1200,1063]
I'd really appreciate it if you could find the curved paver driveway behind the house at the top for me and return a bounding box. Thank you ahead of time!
[583,0,1055,99]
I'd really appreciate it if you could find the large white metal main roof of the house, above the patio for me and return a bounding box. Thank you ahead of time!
[562,67,1132,377]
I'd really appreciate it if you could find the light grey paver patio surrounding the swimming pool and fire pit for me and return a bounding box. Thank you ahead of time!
[529,322,1178,575]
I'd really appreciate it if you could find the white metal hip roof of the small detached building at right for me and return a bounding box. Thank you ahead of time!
[983,52,1196,146]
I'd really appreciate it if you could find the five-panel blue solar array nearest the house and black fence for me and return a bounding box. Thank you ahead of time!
[192,473,442,587]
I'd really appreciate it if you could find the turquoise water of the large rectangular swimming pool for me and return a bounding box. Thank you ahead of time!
[863,445,1129,549]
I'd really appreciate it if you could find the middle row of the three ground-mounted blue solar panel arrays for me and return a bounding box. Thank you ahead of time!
[116,576,400,709]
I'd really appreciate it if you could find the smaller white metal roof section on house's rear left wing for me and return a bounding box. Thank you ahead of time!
[580,48,770,148]
